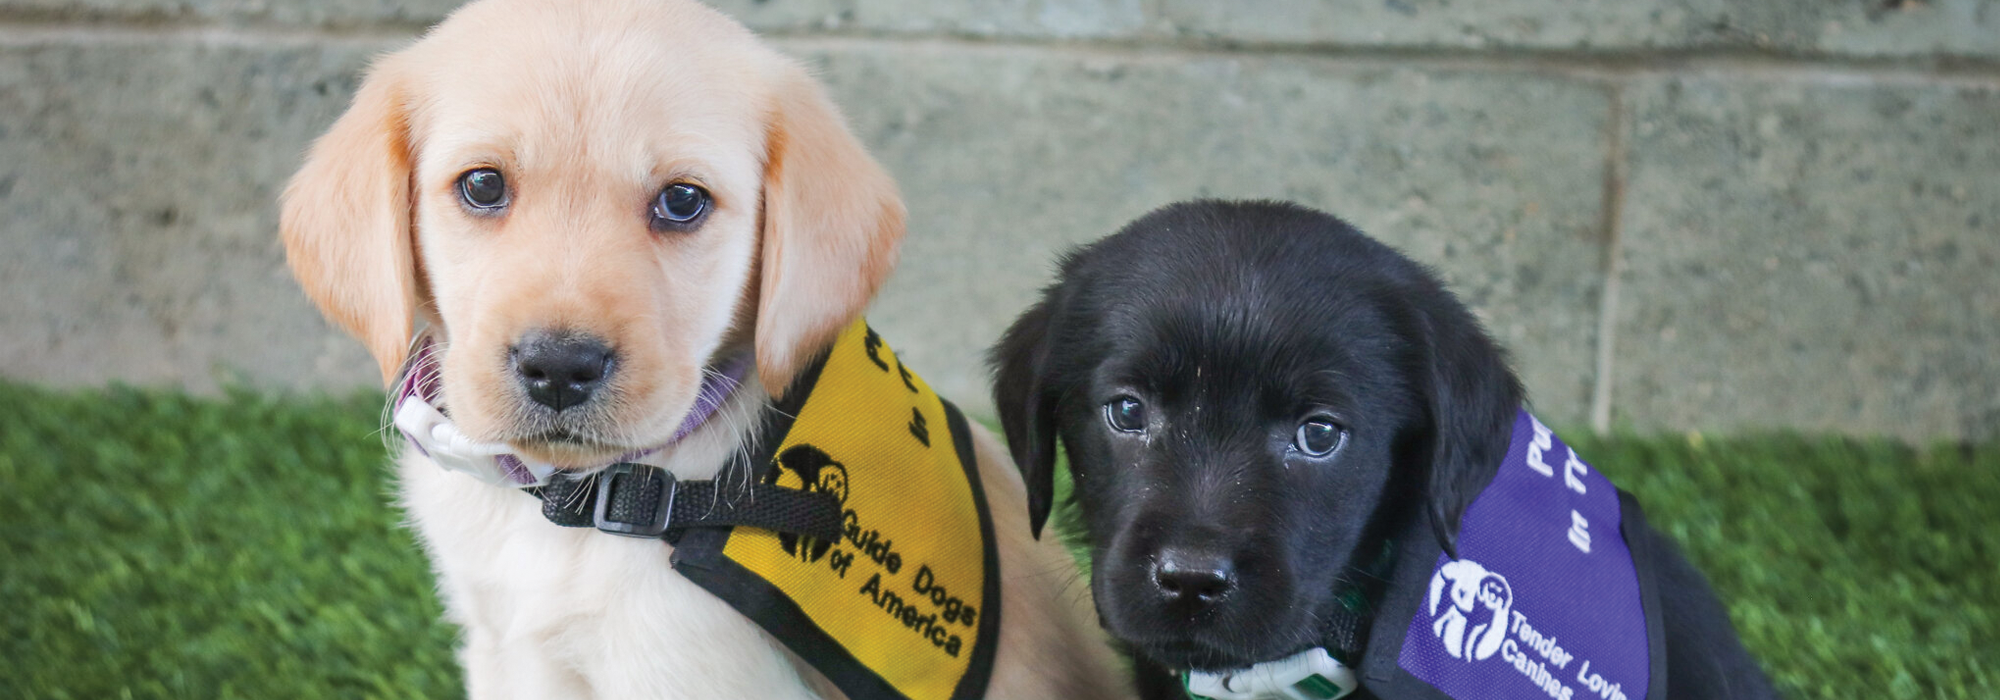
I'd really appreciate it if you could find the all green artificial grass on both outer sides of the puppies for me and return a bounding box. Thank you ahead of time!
[0,384,2000,698]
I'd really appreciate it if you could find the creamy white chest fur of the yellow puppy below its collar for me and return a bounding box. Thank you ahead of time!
[400,380,822,698]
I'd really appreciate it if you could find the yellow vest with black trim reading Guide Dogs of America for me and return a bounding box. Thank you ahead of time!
[674,320,1000,700]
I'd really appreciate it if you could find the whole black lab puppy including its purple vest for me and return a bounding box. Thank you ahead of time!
[992,202,1774,700]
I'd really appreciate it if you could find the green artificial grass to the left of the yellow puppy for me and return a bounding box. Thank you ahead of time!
[0,384,464,700]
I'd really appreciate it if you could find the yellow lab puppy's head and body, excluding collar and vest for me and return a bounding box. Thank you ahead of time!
[282,0,1130,700]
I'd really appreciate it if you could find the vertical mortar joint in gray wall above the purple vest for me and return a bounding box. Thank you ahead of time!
[1590,82,1628,434]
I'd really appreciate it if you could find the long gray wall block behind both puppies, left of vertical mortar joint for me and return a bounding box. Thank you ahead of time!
[0,42,1606,420]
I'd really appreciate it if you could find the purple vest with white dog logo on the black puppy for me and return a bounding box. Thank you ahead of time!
[1398,410,1652,700]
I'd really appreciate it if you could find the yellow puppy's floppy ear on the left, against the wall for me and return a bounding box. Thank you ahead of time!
[278,58,416,384]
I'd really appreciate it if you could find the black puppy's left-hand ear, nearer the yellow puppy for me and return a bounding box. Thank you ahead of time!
[988,294,1056,540]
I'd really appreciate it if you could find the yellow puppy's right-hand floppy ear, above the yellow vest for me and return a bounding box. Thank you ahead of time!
[756,64,904,396]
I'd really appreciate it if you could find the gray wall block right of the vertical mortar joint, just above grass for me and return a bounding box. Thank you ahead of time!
[1614,76,2000,438]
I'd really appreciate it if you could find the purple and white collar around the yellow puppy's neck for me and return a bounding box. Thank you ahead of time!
[394,336,750,486]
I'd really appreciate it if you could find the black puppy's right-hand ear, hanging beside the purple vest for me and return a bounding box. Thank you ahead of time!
[1426,304,1522,560]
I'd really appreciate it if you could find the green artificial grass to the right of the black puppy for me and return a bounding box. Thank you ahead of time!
[1564,430,2000,698]
